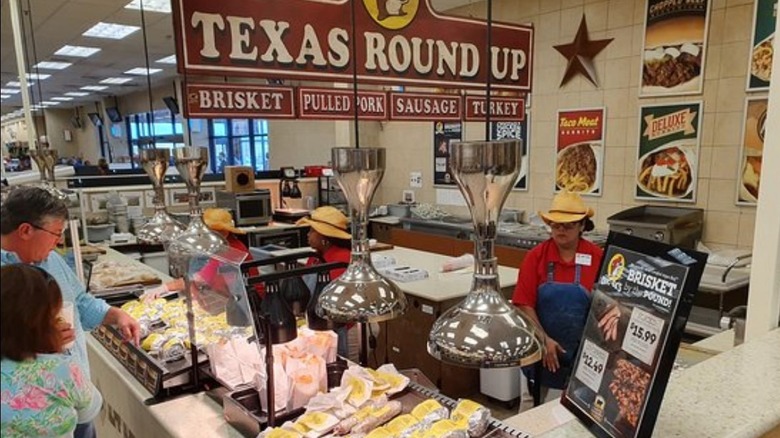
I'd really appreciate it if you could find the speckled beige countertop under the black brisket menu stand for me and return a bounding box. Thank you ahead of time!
[504,328,780,438]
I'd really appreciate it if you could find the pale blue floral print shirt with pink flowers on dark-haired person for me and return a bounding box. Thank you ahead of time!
[0,354,103,438]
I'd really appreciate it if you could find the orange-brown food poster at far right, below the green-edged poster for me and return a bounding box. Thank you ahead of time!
[737,97,769,205]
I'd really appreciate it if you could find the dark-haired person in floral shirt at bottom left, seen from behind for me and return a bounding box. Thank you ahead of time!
[0,264,103,437]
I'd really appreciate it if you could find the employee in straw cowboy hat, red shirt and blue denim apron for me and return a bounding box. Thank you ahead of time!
[512,192,603,400]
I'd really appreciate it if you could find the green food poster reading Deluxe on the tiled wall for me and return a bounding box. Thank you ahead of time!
[634,102,702,202]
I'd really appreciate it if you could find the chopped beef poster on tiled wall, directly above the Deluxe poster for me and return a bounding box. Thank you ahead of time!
[639,0,709,97]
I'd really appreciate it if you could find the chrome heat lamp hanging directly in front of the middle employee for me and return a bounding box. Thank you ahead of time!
[316,148,407,322]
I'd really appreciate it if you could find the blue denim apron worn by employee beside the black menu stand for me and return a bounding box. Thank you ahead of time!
[535,262,590,389]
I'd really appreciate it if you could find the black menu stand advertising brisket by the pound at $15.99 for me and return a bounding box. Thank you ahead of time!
[561,233,707,437]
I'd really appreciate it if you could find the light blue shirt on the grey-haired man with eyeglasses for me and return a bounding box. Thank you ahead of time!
[0,250,110,378]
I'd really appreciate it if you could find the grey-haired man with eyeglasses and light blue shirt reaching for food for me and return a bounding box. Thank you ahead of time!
[0,186,140,437]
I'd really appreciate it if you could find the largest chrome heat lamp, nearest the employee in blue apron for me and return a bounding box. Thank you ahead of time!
[428,140,544,368]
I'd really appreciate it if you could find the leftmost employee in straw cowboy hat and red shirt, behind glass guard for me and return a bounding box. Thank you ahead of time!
[143,208,262,300]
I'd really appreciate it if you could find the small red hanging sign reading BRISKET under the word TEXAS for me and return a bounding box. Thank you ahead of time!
[184,84,295,119]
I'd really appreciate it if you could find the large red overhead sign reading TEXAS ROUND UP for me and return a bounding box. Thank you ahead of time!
[172,0,533,92]
